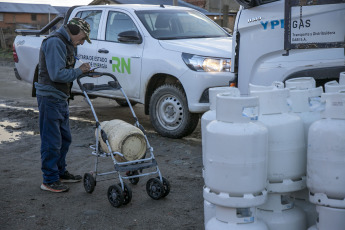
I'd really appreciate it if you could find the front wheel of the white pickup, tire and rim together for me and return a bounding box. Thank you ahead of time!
[149,84,199,139]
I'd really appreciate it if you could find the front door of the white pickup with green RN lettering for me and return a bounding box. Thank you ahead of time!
[96,10,144,100]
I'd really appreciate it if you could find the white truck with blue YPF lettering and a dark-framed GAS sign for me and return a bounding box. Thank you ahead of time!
[231,0,345,95]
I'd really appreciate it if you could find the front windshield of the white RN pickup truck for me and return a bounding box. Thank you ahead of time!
[136,10,230,40]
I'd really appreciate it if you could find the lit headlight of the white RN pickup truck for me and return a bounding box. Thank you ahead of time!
[182,53,231,72]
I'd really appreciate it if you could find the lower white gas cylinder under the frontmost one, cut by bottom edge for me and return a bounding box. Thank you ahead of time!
[205,206,268,230]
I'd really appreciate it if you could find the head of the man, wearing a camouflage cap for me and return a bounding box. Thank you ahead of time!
[67,18,91,47]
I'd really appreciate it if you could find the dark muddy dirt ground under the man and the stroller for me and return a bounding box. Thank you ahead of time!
[0,62,204,230]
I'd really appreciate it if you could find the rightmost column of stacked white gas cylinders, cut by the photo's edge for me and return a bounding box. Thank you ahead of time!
[307,72,345,230]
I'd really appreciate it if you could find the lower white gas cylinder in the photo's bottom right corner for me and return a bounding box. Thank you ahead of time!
[316,205,345,230]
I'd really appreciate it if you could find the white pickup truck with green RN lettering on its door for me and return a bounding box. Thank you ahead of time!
[13,5,234,138]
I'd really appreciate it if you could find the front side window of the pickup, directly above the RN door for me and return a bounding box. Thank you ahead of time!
[105,11,139,42]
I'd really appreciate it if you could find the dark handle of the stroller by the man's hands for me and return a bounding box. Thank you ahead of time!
[77,72,121,92]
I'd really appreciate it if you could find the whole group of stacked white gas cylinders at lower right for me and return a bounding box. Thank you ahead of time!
[201,73,345,230]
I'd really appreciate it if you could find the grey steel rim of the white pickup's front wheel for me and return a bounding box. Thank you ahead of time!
[157,95,183,130]
